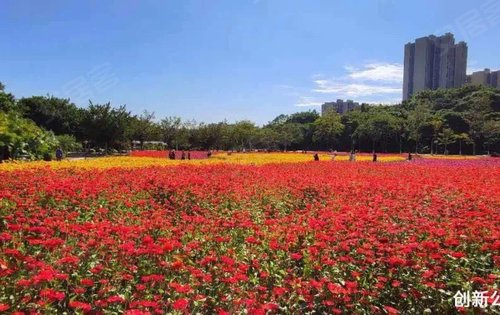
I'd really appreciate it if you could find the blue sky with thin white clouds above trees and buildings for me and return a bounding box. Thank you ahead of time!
[0,0,500,124]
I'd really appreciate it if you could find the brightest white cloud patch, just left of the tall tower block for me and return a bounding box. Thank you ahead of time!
[345,63,404,84]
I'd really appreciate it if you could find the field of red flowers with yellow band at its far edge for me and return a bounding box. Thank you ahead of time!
[0,153,500,314]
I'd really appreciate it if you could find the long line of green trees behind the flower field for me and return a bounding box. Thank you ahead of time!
[0,83,500,159]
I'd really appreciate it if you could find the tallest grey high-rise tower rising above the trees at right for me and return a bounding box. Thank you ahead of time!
[403,33,467,100]
